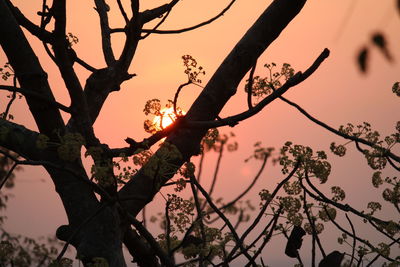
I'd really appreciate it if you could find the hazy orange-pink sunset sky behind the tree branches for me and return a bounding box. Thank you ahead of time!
[0,0,400,266]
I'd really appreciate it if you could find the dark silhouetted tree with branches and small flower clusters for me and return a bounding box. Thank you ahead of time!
[0,0,400,266]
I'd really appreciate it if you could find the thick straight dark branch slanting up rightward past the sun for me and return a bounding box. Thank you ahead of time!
[119,0,306,220]
